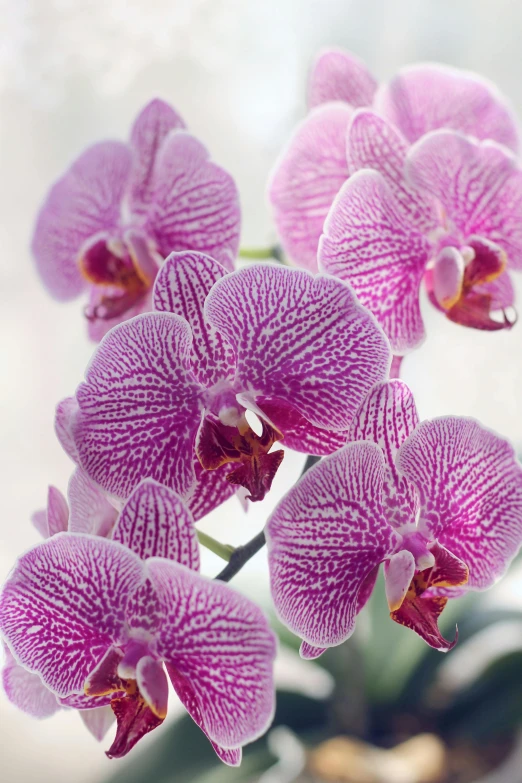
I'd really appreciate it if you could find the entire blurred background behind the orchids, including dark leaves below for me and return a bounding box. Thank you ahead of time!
[0,0,522,783]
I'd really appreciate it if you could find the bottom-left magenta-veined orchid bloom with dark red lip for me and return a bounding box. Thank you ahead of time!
[0,480,275,766]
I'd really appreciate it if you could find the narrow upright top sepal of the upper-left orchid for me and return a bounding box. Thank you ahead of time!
[130,98,185,213]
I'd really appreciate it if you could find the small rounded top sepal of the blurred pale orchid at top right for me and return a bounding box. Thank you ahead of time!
[308,49,377,107]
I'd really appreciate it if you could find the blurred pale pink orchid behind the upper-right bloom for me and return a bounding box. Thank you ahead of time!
[269,50,518,271]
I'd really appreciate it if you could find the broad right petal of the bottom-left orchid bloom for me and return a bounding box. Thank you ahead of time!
[147,559,275,748]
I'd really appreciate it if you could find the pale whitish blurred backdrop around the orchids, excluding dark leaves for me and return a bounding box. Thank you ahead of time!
[0,0,522,783]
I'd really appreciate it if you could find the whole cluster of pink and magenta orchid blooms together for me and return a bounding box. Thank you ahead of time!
[0,51,522,766]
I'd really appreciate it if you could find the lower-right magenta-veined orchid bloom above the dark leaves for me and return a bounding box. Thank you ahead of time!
[266,380,522,658]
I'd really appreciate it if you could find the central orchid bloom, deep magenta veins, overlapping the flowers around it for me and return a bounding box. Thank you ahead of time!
[57,252,390,500]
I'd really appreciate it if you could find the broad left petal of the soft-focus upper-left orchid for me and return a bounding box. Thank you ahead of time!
[31,141,131,300]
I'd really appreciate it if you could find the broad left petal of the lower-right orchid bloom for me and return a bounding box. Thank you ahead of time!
[266,442,400,655]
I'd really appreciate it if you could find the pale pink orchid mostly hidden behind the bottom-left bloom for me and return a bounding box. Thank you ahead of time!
[2,470,117,741]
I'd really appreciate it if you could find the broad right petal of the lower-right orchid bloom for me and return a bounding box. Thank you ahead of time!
[397,416,522,590]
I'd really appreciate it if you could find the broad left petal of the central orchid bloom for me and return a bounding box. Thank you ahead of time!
[73,313,201,498]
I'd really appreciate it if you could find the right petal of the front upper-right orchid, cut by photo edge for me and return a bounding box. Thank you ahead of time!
[406,130,522,269]
